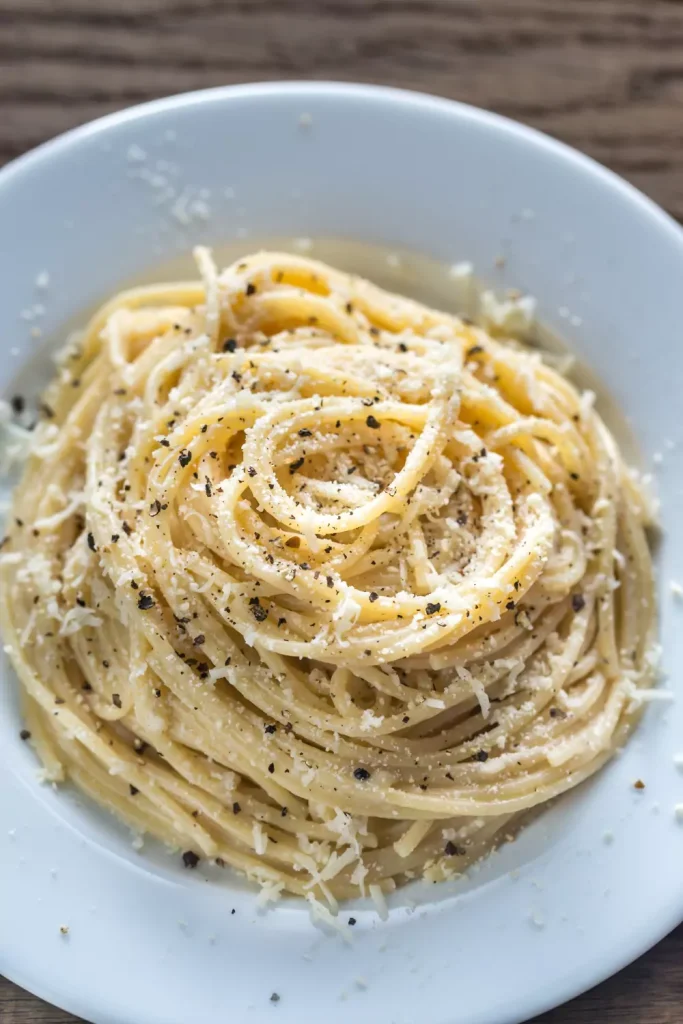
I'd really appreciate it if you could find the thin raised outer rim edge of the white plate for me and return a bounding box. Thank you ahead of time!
[0,80,683,1022]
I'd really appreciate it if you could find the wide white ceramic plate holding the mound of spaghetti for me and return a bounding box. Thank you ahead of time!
[0,84,683,1024]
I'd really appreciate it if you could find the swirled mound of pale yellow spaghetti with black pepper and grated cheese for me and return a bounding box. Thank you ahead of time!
[0,250,654,909]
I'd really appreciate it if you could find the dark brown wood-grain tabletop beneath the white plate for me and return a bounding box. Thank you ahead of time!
[0,0,683,1024]
